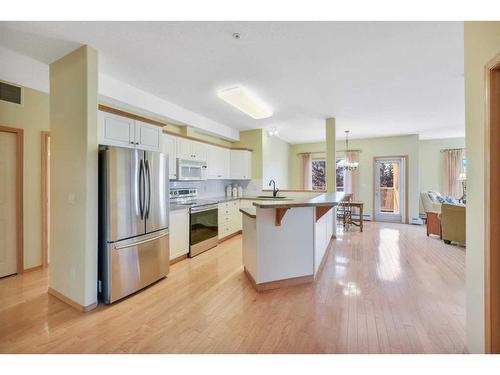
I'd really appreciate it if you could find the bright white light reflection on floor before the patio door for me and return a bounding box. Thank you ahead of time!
[377,228,401,281]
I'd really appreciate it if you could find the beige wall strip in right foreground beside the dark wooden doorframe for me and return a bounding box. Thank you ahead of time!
[464,22,500,353]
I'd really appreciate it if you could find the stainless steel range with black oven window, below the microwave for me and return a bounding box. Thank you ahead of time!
[170,188,219,258]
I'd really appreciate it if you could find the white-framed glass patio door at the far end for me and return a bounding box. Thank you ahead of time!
[374,157,406,223]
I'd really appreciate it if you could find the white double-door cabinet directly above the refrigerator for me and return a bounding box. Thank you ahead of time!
[99,111,161,151]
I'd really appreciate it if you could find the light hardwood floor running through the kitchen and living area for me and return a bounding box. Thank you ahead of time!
[0,223,465,353]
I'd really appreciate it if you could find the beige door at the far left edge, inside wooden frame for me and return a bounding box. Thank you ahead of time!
[0,131,18,277]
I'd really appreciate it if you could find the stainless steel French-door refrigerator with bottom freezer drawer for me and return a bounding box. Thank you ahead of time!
[98,146,170,303]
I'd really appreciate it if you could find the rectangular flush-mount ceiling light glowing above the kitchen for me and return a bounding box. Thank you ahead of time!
[217,86,273,120]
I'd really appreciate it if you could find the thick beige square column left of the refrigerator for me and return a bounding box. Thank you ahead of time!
[49,46,98,311]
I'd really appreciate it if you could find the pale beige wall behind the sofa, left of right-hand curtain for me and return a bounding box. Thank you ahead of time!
[418,138,465,213]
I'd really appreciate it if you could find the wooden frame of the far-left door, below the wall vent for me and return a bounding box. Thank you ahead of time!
[0,125,24,274]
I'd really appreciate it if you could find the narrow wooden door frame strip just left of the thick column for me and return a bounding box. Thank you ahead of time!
[41,131,50,268]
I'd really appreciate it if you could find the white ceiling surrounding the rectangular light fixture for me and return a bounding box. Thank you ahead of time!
[0,22,465,143]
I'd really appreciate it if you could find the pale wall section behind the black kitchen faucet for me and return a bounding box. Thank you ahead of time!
[262,131,289,189]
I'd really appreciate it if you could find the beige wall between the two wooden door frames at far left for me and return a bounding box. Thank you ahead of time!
[0,82,50,269]
